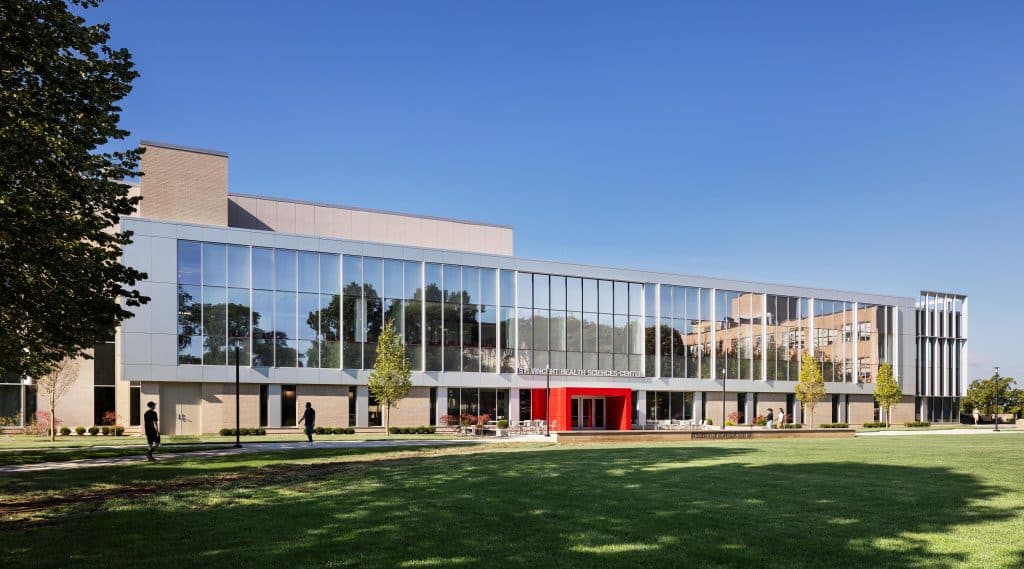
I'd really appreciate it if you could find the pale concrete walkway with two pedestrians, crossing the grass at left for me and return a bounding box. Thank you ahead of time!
[0,437,495,476]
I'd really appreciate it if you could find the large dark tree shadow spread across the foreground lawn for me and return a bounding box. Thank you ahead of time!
[0,446,1014,568]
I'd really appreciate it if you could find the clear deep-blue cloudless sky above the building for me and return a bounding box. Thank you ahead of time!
[89,0,1024,383]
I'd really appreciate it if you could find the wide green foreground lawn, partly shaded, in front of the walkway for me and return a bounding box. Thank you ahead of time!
[0,435,1024,568]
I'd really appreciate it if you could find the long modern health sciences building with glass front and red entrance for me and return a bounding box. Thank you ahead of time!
[0,141,967,434]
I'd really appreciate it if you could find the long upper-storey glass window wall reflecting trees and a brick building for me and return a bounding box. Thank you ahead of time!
[177,240,897,382]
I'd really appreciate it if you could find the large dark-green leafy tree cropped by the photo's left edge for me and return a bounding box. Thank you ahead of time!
[0,0,148,378]
